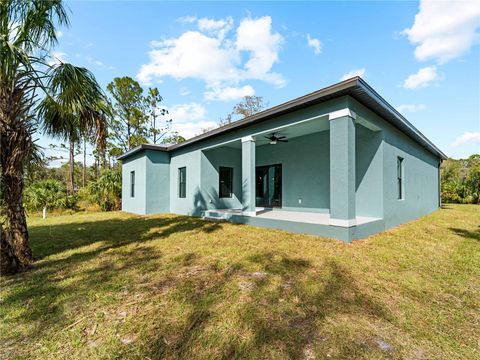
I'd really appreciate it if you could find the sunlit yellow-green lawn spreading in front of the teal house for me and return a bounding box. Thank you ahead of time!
[0,205,480,359]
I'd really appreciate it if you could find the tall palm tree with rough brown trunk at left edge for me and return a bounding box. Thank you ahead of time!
[0,0,107,274]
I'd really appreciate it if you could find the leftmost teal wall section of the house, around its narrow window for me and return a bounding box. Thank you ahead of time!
[122,152,147,215]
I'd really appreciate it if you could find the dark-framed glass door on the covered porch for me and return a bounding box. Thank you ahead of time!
[255,164,282,207]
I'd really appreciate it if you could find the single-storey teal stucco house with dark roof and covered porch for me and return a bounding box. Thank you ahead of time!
[119,77,446,242]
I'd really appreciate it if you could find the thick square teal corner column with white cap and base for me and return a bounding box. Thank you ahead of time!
[329,109,356,227]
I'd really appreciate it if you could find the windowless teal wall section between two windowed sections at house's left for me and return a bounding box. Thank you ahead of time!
[145,150,170,214]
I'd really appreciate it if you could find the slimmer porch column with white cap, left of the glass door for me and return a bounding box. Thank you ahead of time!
[242,136,256,215]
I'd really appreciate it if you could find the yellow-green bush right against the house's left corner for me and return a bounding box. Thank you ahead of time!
[88,170,122,211]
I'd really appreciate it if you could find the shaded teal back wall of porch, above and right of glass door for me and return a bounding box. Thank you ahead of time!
[256,131,330,213]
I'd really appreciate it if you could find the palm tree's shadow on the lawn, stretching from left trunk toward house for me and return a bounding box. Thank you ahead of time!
[2,216,221,352]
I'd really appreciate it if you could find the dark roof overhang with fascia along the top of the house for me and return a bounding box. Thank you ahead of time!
[118,76,447,159]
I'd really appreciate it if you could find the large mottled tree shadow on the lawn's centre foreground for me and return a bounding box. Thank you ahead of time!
[142,252,392,359]
